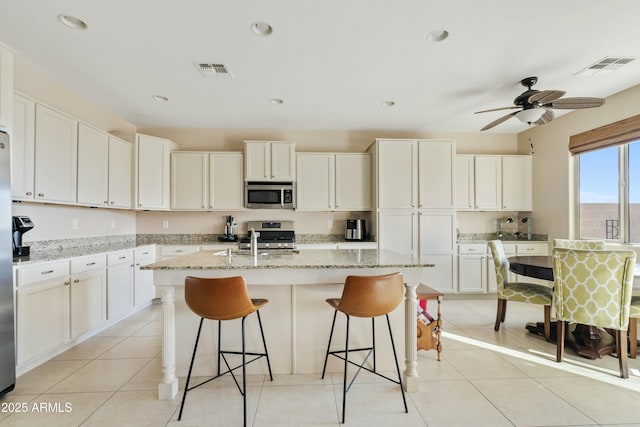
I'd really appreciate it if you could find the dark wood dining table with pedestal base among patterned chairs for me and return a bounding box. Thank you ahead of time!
[508,255,640,359]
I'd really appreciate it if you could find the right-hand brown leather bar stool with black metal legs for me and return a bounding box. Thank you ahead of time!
[322,273,409,424]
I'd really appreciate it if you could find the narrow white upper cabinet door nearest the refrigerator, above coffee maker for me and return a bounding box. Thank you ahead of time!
[11,94,36,200]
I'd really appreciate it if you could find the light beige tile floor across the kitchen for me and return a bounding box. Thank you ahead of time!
[0,299,640,427]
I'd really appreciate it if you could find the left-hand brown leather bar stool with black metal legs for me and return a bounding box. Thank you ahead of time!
[178,276,273,426]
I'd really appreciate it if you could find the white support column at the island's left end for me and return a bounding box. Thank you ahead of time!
[158,286,179,400]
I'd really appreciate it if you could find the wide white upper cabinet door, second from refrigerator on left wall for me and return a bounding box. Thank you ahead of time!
[35,104,78,204]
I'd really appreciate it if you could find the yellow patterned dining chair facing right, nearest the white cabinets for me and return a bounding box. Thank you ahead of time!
[489,240,553,341]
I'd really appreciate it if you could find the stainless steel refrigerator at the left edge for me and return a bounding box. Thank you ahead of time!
[0,131,16,395]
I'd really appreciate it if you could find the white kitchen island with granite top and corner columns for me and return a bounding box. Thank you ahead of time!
[142,249,433,400]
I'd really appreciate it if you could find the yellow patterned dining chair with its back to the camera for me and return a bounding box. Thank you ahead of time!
[553,248,636,378]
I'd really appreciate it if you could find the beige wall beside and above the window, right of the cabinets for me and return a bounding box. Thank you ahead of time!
[518,86,640,244]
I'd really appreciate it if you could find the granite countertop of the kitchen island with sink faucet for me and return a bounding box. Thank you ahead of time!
[141,249,434,270]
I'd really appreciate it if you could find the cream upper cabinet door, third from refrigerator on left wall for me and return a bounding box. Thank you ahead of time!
[77,123,109,206]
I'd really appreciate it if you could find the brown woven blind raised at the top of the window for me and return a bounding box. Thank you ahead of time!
[569,115,640,154]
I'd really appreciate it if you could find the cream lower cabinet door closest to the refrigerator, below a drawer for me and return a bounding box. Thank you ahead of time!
[16,277,70,365]
